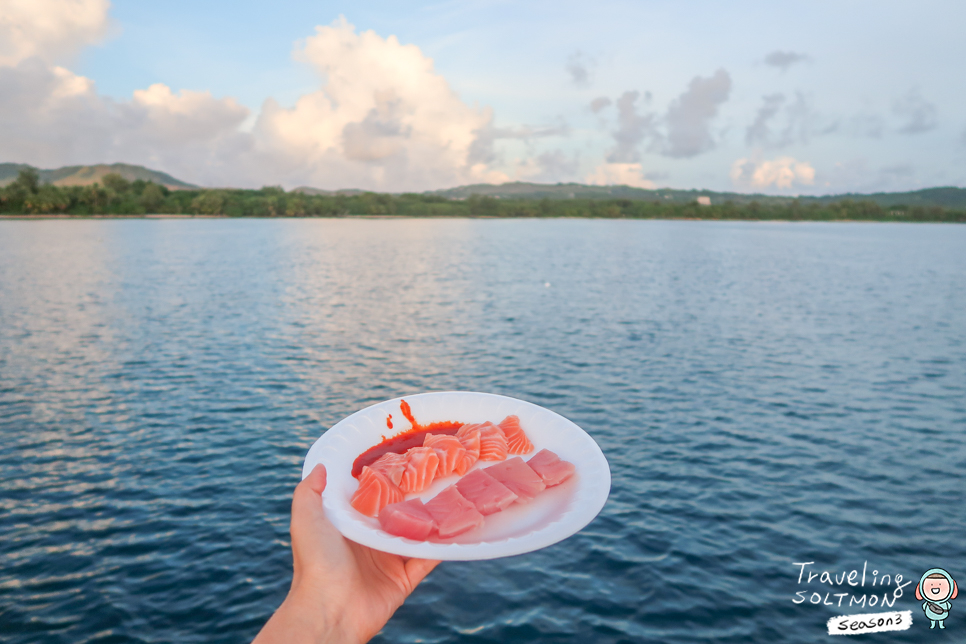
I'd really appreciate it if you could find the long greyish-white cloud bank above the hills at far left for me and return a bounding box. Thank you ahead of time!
[0,58,250,181]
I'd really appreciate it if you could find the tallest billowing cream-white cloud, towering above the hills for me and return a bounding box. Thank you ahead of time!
[254,18,506,190]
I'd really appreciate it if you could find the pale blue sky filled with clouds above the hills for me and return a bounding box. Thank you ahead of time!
[0,0,966,194]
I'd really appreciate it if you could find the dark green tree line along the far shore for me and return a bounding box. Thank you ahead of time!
[0,169,966,223]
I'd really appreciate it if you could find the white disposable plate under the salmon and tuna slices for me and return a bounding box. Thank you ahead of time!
[302,391,610,561]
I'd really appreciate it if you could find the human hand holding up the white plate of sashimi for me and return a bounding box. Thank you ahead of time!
[253,465,439,644]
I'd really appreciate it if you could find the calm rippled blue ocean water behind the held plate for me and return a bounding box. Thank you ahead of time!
[0,220,966,644]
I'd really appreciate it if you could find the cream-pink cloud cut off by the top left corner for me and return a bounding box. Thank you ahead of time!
[0,0,110,66]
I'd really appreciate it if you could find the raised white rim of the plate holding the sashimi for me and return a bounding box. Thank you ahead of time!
[302,390,611,561]
